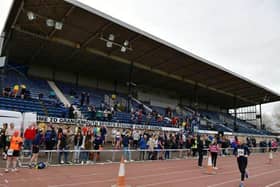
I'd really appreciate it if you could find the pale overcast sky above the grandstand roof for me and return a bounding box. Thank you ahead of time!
[0,0,280,113]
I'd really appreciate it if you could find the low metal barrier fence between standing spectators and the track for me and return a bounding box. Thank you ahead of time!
[0,147,279,168]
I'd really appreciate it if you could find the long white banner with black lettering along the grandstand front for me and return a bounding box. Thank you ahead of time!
[37,116,180,131]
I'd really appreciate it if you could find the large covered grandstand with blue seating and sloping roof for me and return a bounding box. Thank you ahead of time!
[0,0,280,135]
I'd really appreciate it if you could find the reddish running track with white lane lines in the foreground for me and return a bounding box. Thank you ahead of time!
[0,153,280,187]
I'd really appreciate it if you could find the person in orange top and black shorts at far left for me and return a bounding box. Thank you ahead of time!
[5,130,23,172]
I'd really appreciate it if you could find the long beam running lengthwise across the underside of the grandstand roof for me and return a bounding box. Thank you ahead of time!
[12,26,255,104]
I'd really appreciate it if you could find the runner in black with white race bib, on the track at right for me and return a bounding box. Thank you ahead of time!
[234,141,250,187]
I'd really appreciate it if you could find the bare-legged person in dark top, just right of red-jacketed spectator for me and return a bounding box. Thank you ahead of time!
[29,129,43,168]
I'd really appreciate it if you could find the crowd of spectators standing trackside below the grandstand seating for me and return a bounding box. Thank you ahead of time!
[0,123,278,167]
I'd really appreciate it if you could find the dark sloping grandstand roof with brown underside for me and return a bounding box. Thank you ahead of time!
[3,0,280,108]
